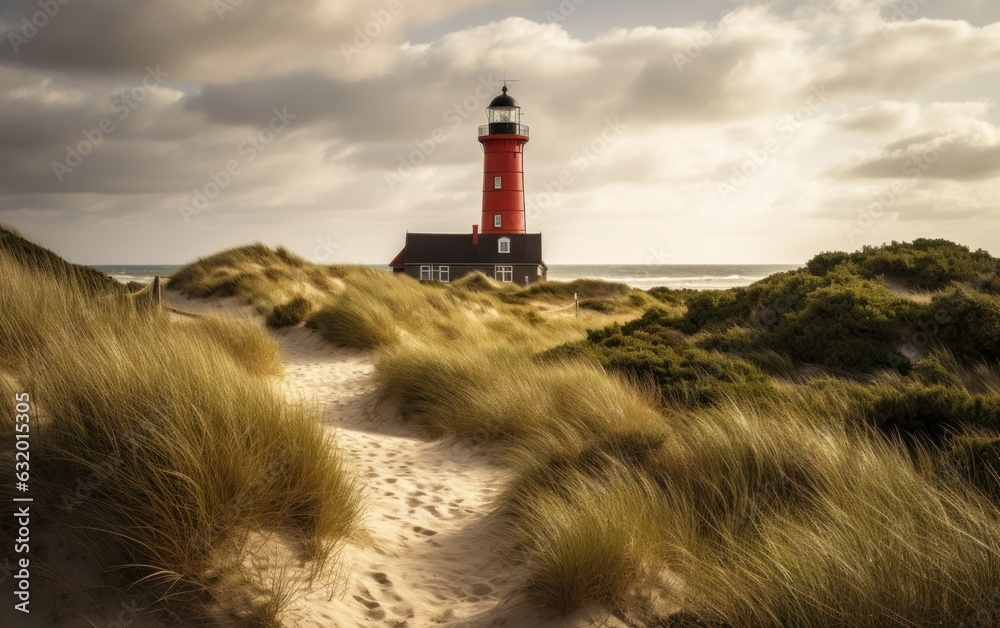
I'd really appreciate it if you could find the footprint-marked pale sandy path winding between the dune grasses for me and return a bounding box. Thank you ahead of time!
[277,328,509,626]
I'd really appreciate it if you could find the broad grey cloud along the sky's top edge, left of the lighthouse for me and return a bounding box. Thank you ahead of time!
[0,0,500,81]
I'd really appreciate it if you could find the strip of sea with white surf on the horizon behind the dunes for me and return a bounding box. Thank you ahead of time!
[94,264,799,290]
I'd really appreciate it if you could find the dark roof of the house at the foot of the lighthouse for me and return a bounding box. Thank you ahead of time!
[393,233,543,264]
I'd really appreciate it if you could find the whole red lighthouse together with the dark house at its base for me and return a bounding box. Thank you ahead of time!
[389,84,548,285]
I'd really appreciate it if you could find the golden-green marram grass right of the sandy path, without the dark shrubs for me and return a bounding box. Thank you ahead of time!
[166,243,1000,626]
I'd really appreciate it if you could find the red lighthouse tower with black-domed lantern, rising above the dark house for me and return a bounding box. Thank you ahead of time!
[479,83,528,234]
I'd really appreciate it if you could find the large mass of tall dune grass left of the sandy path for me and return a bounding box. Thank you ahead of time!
[0,233,361,625]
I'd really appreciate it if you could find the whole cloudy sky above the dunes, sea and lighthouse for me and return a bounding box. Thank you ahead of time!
[0,0,1000,264]
